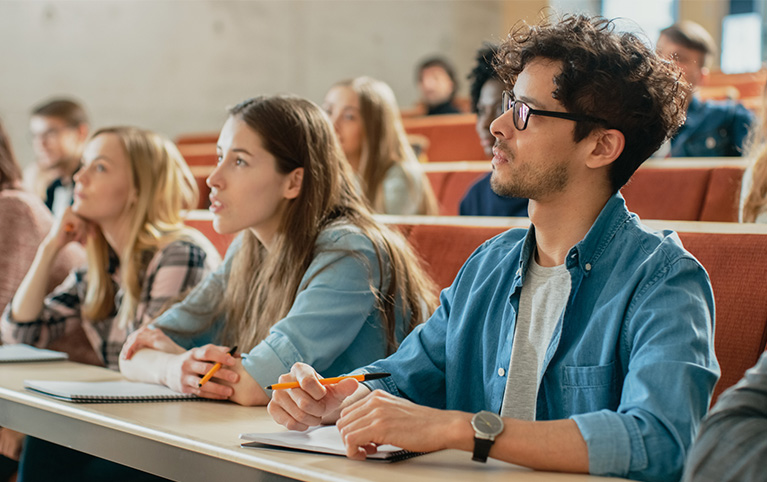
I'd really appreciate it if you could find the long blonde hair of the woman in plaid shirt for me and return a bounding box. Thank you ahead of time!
[83,127,206,327]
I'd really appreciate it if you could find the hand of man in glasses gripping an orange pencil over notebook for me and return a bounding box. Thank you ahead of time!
[267,363,370,430]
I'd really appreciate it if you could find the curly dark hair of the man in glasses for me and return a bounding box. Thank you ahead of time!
[496,15,690,192]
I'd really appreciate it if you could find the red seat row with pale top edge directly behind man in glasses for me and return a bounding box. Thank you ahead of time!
[183,211,767,400]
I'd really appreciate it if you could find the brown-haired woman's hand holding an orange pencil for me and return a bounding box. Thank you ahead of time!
[163,345,240,400]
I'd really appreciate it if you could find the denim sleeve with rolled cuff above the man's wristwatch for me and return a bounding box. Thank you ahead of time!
[572,258,719,481]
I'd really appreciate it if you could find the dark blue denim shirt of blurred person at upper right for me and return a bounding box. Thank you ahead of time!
[669,97,754,157]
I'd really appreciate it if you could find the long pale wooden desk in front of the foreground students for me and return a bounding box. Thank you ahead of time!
[0,362,621,482]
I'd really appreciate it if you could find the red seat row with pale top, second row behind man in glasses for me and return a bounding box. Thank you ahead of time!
[423,158,746,222]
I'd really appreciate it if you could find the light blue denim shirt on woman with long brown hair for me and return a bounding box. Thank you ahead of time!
[154,224,409,392]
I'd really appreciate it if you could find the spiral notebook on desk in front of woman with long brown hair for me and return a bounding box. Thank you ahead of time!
[24,380,202,403]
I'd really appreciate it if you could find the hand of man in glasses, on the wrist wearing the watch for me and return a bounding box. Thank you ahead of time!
[336,390,474,459]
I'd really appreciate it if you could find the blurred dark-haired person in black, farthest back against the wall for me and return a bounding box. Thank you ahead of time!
[417,57,461,115]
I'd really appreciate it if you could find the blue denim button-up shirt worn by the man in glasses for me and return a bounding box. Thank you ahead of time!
[360,194,719,480]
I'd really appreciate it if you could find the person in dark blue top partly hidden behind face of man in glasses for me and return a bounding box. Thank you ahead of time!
[459,45,527,217]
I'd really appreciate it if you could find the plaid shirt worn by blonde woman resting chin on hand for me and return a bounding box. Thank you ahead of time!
[0,240,218,370]
